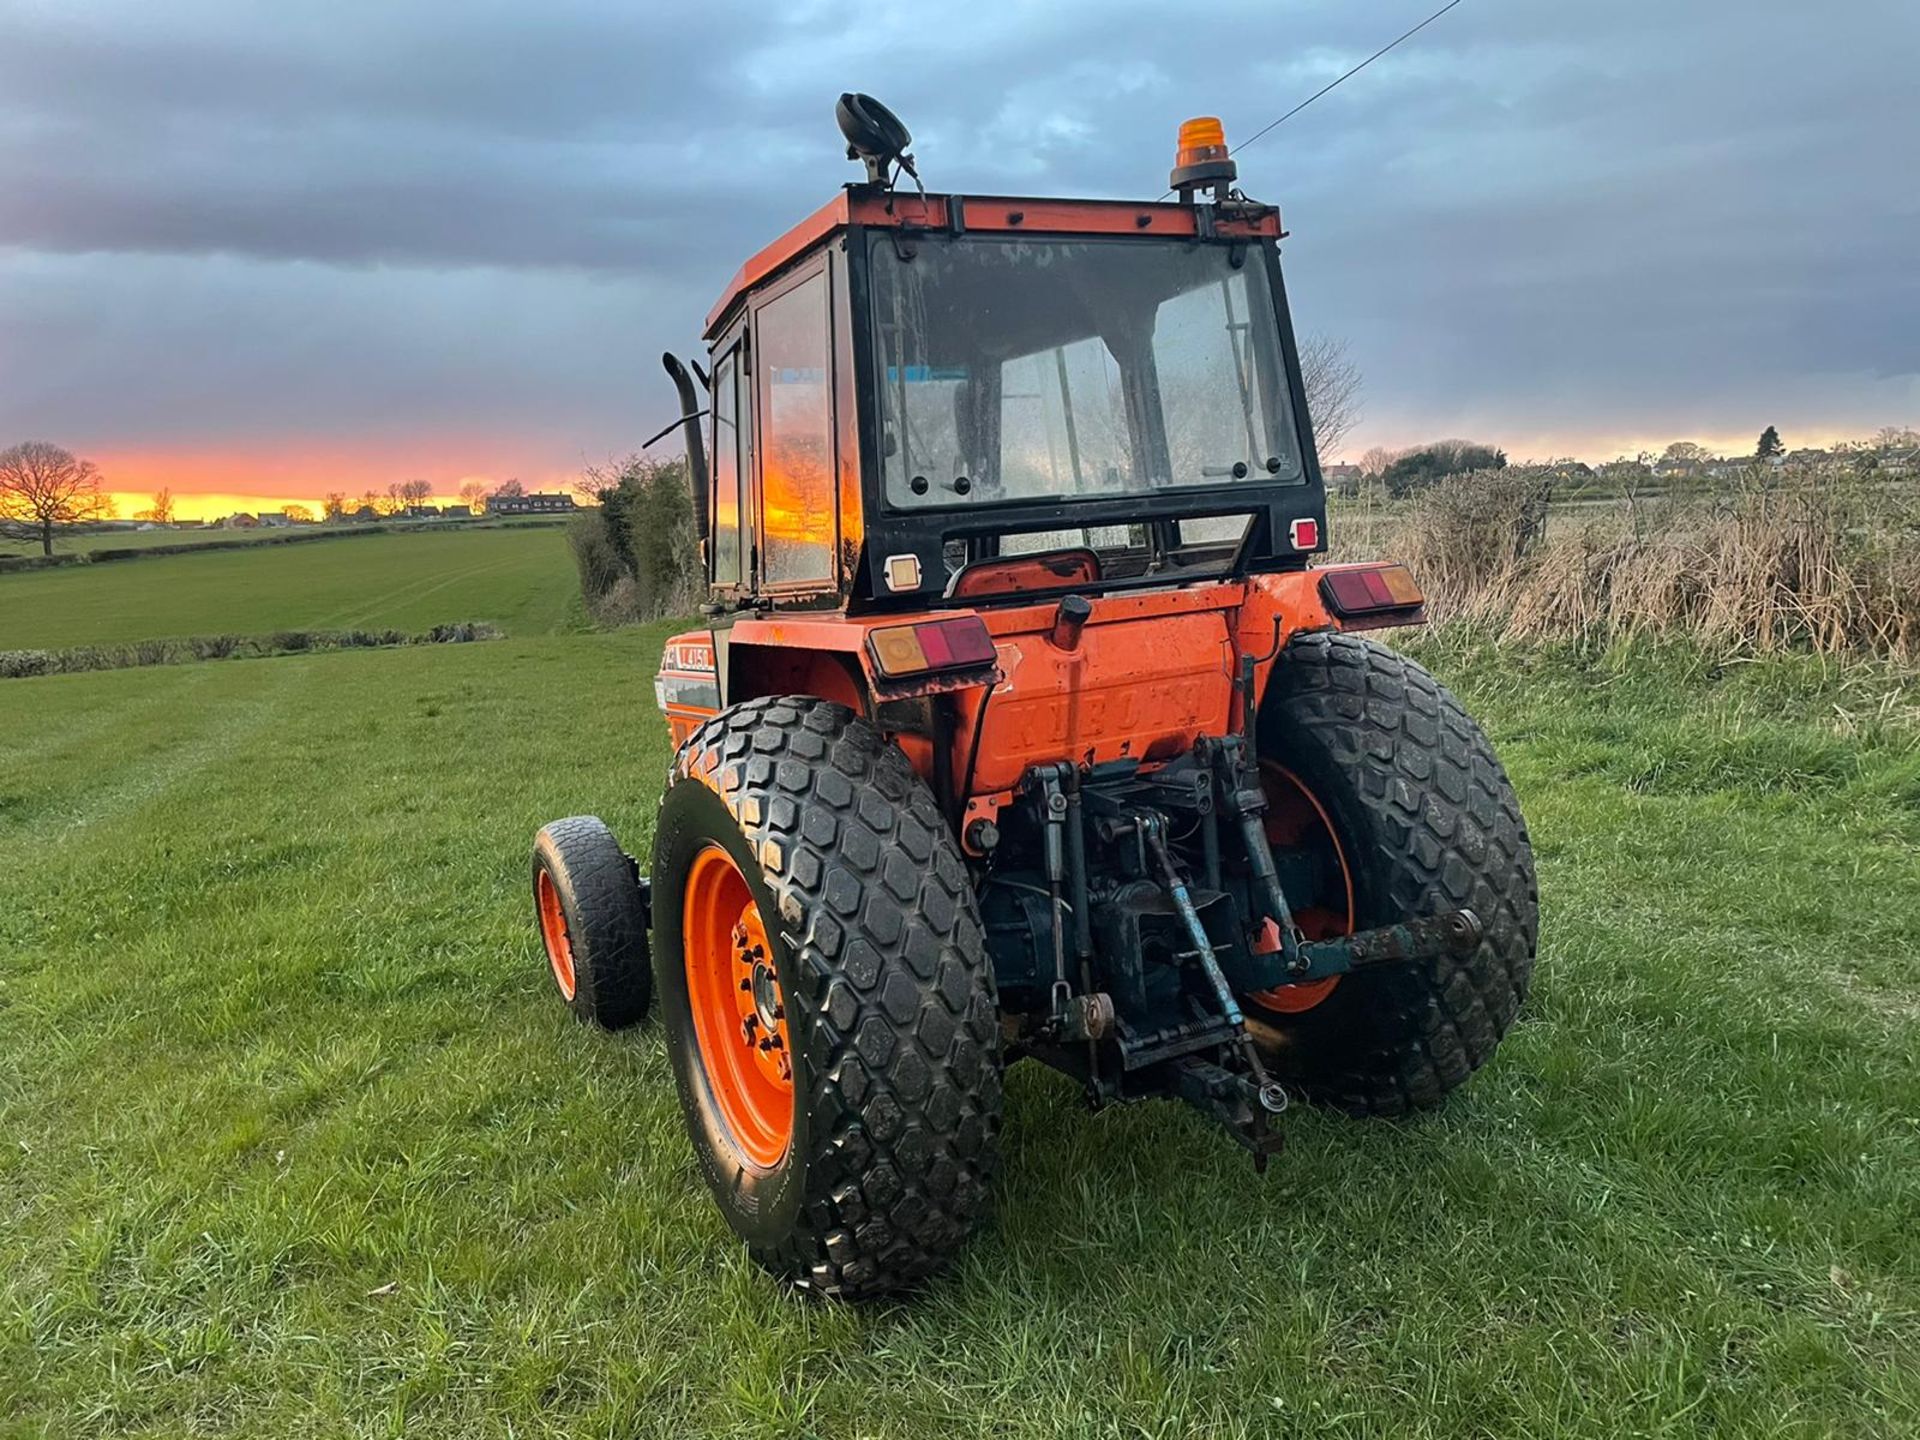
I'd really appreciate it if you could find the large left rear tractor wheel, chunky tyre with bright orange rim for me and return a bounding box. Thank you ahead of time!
[653,697,1000,1298]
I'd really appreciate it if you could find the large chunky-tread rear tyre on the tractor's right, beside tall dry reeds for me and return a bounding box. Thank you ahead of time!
[1246,634,1540,1116]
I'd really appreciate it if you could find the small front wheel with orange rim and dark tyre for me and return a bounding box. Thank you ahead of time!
[534,816,653,1029]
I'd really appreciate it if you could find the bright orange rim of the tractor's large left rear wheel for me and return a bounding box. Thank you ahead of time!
[682,845,793,1169]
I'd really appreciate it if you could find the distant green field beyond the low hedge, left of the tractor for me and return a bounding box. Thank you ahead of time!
[0,526,578,649]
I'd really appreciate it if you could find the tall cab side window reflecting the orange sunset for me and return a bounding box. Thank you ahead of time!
[753,271,835,586]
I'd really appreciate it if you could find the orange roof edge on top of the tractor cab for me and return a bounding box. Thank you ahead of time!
[703,184,1284,340]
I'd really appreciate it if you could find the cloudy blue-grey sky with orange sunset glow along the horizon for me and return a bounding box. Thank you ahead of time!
[0,0,1920,515]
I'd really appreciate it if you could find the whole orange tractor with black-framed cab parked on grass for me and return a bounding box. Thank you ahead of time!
[534,94,1538,1296]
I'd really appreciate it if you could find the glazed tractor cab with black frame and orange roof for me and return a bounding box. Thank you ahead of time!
[668,115,1325,614]
